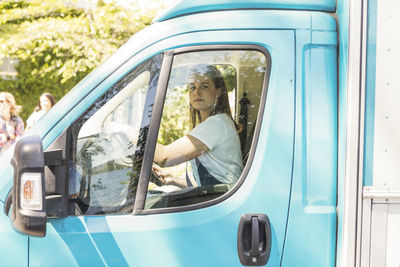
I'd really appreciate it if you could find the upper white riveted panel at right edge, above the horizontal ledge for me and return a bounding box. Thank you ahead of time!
[373,0,400,189]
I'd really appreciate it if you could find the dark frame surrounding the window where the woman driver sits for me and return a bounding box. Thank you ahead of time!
[132,44,272,215]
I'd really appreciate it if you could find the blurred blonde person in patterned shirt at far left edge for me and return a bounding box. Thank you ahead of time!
[0,92,25,154]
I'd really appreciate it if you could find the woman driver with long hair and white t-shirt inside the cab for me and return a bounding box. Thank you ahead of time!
[154,65,243,186]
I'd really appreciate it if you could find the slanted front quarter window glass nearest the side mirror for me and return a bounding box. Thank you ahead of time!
[69,56,162,215]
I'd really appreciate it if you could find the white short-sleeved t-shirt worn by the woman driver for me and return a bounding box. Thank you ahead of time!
[189,113,243,185]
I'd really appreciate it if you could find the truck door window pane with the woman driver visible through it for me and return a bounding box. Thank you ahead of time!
[145,50,267,209]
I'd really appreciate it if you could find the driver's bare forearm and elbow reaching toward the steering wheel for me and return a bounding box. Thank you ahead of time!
[154,135,210,167]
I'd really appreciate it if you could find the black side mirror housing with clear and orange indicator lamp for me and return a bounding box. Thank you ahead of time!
[10,136,46,237]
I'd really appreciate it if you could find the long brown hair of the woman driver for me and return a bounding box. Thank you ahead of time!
[188,64,238,129]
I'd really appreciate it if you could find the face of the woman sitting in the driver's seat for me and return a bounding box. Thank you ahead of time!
[189,75,221,115]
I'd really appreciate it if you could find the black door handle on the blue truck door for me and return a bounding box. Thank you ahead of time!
[237,213,271,266]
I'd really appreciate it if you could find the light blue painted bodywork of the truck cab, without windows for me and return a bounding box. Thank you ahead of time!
[0,0,394,266]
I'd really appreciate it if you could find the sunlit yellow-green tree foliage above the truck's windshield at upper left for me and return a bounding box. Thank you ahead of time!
[0,0,155,119]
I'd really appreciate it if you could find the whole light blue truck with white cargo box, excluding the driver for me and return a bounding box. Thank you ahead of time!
[0,0,400,266]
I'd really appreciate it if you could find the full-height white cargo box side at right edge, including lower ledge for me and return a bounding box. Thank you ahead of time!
[360,0,400,267]
